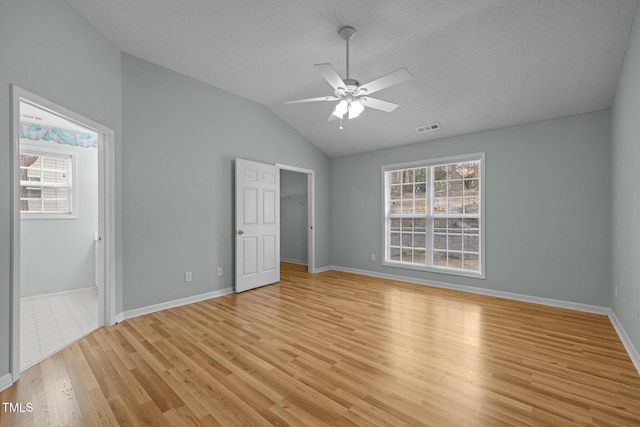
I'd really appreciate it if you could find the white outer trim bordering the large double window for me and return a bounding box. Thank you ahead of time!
[381,152,486,279]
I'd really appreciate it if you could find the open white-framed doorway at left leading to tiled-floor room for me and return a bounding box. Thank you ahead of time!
[11,86,115,382]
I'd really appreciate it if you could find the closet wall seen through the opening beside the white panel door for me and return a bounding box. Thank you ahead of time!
[280,170,308,264]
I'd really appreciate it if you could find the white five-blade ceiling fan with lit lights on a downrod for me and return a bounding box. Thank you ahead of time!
[287,26,411,129]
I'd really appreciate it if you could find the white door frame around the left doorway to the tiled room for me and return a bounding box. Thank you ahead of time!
[10,85,116,383]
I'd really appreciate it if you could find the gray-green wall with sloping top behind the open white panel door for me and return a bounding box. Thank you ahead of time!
[122,54,330,310]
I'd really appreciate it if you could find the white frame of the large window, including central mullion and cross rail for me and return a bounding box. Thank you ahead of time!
[381,152,486,279]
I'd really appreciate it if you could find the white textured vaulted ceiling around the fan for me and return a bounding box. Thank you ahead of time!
[67,0,637,157]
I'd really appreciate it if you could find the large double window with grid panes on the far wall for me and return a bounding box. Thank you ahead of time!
[382,153,484,277]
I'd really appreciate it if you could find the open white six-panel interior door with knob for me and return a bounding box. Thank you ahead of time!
[235,159,280,292]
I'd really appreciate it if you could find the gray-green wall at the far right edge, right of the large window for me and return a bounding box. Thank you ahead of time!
[610,3,640,350]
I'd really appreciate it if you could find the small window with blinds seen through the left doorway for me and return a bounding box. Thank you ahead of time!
[20,148,76,218]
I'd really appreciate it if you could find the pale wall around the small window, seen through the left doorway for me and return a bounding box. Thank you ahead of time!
[20,139,98,297]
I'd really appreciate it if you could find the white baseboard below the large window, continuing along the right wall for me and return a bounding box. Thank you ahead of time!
[328,265,640,373]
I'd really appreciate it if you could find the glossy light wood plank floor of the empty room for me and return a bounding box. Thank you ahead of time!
[0,264,640,427]
